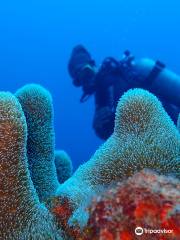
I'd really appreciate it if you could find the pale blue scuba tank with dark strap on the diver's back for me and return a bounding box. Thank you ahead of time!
[132,58,180,108]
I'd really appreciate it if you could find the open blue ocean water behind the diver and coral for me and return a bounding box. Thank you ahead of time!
[0,0,180,168]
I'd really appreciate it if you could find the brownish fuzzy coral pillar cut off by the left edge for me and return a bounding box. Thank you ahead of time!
[0,92,61,240]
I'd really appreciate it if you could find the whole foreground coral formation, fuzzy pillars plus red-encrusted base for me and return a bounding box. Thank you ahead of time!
[0,84,180,240]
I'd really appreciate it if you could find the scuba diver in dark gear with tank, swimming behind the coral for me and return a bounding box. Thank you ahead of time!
[68,45,180,140]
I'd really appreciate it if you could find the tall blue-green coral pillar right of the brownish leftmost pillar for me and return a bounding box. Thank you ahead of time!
[16,84,59,201]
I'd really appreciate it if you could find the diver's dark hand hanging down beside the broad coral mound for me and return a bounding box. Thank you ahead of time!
[93,106,115,139]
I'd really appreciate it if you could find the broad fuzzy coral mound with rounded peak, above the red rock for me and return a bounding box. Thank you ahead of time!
[54,89,180,225]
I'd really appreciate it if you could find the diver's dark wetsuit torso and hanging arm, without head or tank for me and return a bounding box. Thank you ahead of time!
[93,58,180,139]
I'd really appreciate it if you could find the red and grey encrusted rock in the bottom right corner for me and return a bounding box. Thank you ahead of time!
[82,171,180,240]
